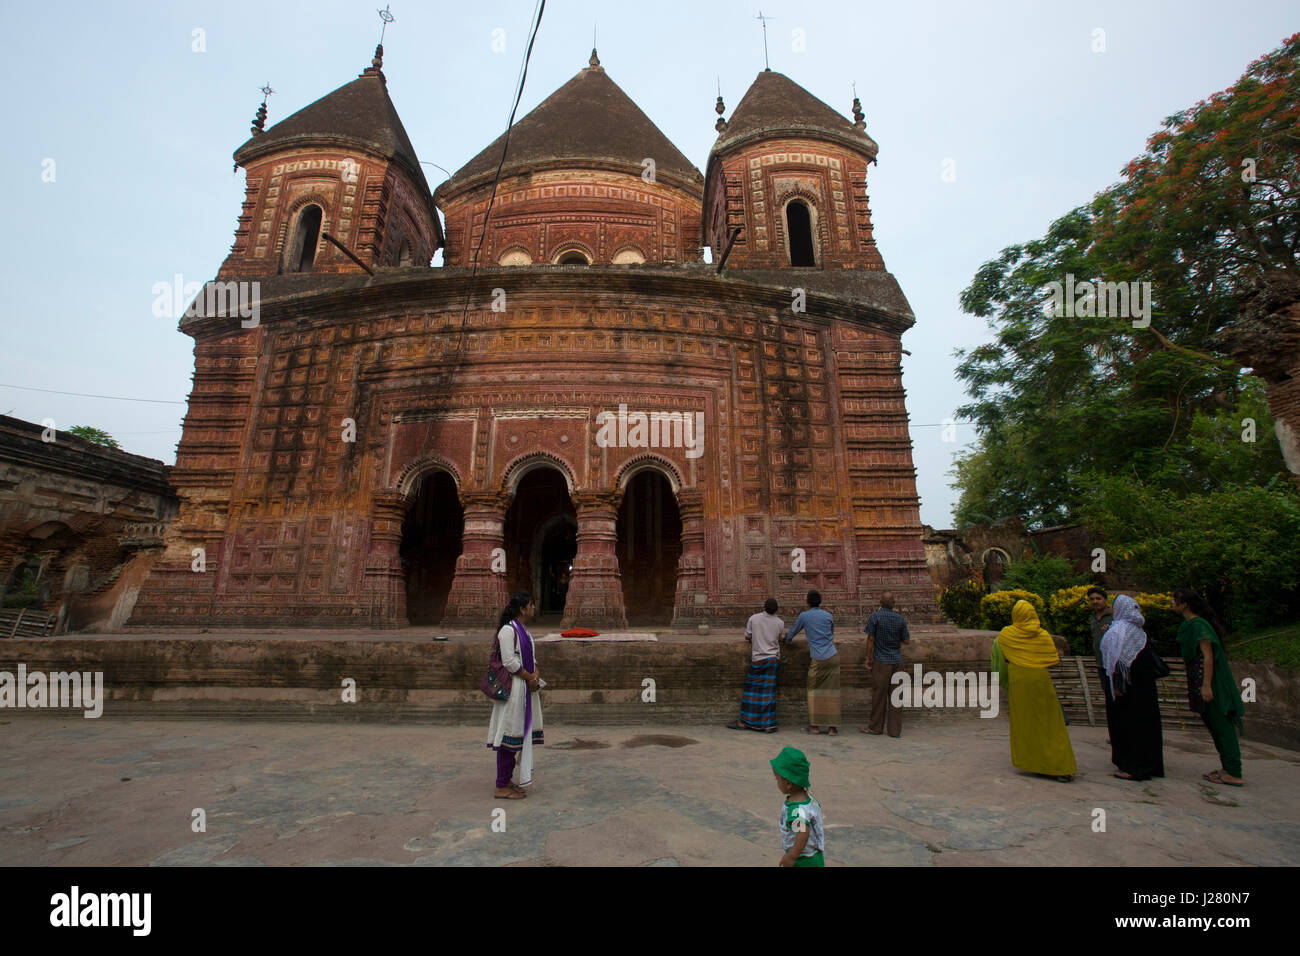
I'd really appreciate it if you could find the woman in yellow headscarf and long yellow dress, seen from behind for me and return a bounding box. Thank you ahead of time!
[991,601,1078,783]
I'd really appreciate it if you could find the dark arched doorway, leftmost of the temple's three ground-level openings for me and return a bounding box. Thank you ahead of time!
[402,471,465,626]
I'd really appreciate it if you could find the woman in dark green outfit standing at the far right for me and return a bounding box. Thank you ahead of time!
[1174,588,1245,787]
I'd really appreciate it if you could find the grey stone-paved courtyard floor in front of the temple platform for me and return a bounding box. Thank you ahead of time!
[0,715,1300,866]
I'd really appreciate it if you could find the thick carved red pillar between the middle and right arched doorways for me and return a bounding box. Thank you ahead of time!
[560,492,628,628]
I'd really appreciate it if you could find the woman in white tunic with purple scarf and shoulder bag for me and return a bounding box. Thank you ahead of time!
[488,591,545,800]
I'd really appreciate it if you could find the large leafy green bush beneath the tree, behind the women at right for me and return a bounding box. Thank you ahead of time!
[1084,475,1300,630]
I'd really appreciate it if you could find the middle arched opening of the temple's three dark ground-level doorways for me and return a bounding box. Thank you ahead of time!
[504,466,577,623]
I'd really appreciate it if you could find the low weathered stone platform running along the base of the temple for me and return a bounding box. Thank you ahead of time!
[0,627,993,726]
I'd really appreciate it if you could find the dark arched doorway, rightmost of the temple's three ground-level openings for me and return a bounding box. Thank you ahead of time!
[615,470,681,624]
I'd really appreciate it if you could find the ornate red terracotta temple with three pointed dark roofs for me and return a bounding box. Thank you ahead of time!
[129,44,940,628]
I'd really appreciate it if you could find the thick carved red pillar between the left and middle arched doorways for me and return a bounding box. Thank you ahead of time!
[441,492,510,627]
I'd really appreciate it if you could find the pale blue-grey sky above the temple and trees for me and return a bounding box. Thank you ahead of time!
[0,0,1300,528]
